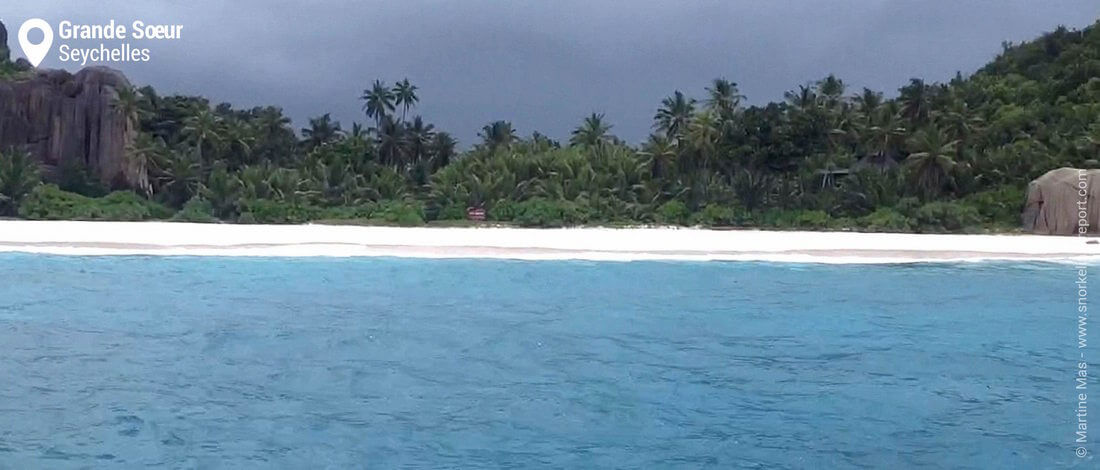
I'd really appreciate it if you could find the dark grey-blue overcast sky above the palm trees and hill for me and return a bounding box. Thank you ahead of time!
[0,0,1100,146]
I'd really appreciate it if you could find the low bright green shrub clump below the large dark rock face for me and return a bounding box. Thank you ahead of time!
[19,185,172,220]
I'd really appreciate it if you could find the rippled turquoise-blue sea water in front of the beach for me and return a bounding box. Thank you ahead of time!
[0,254,1095,469]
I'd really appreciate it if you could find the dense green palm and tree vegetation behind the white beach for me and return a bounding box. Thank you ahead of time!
[0,21,1100,231]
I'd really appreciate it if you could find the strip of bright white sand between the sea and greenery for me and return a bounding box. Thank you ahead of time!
[0,220,1100,263]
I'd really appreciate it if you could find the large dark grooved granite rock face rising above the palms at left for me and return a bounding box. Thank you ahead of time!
[0,67,133,186]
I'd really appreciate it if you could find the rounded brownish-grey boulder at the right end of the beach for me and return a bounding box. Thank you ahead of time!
[1023,168,1100,236]
